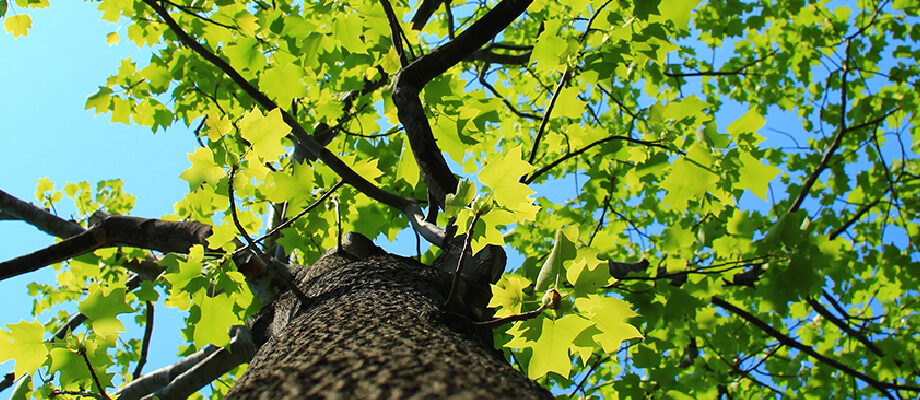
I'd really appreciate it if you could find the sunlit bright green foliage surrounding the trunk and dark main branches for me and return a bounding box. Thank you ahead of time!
[0,0,920,399]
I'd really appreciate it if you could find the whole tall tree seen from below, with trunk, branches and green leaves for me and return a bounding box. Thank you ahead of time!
[0,0,920,398]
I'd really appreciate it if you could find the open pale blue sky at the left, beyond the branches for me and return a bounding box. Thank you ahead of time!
[0,1,197,374]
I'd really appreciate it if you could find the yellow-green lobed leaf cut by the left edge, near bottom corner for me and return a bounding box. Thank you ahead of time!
[0,321,51,376]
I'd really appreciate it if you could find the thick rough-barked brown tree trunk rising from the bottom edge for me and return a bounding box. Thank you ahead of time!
[228,248,552,399]
